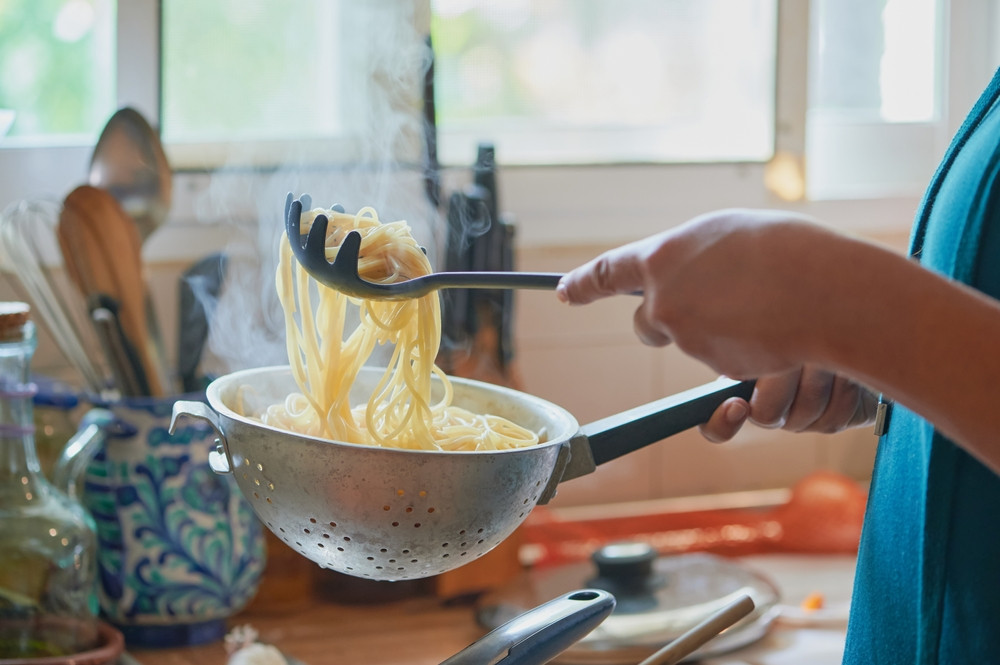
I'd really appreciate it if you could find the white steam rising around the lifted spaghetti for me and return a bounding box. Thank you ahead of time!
[191,1,441,375]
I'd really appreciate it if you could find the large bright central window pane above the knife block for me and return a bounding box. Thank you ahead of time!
[431,0,776,164]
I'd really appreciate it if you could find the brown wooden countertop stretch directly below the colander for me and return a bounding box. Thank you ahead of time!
[129,597,484,665]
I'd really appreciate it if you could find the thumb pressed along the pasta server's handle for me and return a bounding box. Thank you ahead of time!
[556,245,644,305]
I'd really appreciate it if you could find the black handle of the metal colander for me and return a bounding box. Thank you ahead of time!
[562,377,755,480]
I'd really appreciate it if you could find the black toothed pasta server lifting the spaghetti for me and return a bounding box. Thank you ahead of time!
[285,193,562,300]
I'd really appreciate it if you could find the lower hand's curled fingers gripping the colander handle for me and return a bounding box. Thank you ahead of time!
[700,366,877,443]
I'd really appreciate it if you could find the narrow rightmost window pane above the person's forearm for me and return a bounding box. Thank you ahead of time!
[806,0,945,199]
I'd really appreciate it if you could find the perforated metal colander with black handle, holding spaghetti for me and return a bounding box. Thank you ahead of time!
[174,366,752,580]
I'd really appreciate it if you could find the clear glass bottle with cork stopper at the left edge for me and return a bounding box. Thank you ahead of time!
[0,303,98,659]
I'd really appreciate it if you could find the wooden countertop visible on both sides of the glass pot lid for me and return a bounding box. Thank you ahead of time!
[129,554,854,665]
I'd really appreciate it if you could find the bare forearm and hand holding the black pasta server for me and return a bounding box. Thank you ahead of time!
[557,210,1000,471]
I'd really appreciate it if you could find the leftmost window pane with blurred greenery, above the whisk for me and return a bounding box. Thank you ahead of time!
[0,0,115,146]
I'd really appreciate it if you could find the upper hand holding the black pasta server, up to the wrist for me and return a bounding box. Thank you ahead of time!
[556,210,859,378]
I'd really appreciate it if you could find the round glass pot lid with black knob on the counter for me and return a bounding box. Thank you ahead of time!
[477,542,779,665]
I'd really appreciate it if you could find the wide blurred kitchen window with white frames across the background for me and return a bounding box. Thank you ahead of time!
[0,0,1000,251]
